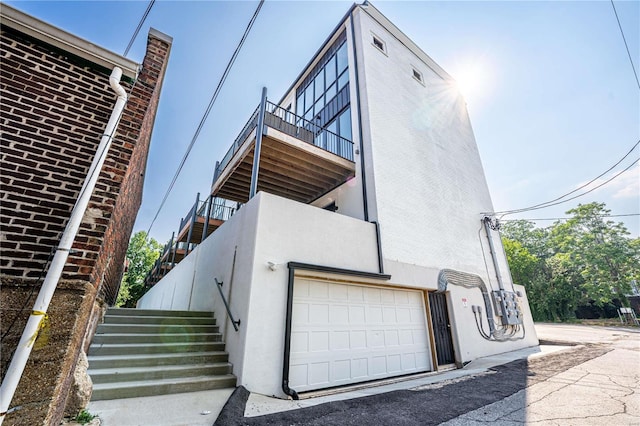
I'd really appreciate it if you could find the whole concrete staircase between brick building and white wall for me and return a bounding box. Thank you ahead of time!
[88,308,236,401]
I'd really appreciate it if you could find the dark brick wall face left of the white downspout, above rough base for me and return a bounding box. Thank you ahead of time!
[0,28,117,278]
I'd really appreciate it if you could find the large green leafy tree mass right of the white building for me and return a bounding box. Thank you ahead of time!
[502,203,640,321]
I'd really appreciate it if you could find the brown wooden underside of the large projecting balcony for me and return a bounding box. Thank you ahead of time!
[212,127,355,203]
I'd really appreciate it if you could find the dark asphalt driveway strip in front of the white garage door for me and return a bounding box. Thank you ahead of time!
[215,343,608,426]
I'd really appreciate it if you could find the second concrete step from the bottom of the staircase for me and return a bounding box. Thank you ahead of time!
[89,362,231,384]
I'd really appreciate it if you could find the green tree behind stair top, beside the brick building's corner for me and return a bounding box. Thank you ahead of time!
[116,231,162,308]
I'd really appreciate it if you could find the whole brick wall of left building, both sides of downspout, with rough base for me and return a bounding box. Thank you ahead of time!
[0,26,171,425]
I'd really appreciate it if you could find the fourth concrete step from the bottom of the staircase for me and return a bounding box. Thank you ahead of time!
[87,342,225,356]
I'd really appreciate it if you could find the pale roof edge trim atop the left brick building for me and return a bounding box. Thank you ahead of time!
[0,3,139,79]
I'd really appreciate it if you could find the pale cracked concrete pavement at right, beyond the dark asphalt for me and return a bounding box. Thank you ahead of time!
[444,324,640,426]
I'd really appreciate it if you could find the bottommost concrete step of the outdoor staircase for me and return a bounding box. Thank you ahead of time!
[91,374,236,401]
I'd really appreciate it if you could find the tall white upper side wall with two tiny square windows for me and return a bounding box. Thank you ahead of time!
[355,9,512,284]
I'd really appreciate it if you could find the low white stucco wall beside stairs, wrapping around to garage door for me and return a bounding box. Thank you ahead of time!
[138,192,378,396]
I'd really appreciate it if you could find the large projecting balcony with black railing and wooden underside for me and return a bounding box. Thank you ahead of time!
[211,102,355,203]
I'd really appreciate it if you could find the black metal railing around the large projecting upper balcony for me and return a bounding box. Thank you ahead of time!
[214,101,353,182]
